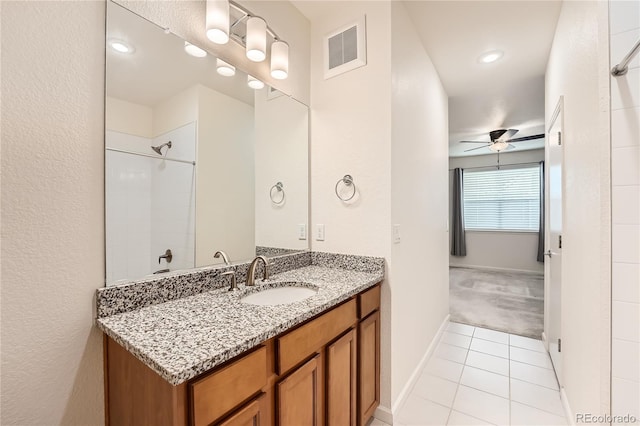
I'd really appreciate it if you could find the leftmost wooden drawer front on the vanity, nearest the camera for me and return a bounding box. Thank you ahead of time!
[189,346,267,426]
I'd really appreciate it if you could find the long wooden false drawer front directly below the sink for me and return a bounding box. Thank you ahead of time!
[276,299,357,374]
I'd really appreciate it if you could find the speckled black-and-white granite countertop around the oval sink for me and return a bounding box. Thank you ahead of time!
[97,266,383,385]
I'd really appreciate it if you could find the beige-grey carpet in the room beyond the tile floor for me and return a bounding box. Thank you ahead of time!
[449,267,544,339]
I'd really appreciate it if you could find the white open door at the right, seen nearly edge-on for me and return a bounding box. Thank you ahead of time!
[545,98,563,385]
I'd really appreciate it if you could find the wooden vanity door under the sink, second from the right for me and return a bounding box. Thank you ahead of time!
[325,329,357,426]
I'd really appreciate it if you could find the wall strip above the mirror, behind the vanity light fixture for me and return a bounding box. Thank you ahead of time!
[117,0,309,105]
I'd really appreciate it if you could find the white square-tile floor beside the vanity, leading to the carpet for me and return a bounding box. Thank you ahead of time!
[372,323,567,426]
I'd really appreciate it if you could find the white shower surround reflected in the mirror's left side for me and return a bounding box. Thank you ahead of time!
[105,123,196,283]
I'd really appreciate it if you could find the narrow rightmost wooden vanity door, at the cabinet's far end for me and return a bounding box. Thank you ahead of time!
[358,311,380,425]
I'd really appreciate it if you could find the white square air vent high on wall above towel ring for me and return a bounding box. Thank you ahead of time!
[324,16,367,79]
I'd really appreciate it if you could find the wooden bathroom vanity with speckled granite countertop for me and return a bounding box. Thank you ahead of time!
[98,253,383,426]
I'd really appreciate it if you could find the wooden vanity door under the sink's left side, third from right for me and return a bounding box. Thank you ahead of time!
[276,355,321,426]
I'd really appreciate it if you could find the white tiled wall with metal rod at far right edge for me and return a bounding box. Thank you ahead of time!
[609,1,640,418]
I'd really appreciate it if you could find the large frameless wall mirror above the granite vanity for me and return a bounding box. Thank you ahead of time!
[105,2,309,285]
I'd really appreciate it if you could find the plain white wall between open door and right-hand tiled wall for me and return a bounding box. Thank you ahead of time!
[545,1,611,414]
